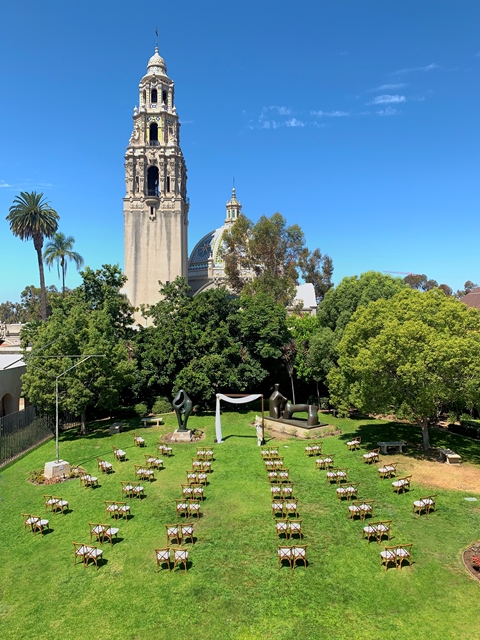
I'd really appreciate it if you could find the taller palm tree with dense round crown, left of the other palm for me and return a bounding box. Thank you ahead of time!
[7,191,60,321]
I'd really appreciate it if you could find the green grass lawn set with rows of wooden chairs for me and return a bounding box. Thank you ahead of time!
[0,413,480,640]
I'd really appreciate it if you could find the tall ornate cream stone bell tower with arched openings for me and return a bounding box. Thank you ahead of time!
[123,47,189,320]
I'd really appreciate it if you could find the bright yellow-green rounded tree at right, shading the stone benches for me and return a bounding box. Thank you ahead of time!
[328,289,480,449]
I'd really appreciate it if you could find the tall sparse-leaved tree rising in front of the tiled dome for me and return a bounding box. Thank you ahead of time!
[222,213,333,305]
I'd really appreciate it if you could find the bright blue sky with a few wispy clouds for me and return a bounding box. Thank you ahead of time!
[0,0,480,301]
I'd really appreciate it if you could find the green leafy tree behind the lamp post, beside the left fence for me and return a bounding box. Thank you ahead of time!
[22,284,135,433]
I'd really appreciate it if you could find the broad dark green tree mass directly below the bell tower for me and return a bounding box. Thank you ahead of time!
[135,278,288,403]
